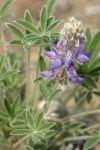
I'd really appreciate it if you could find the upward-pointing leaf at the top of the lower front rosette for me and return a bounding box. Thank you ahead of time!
[26,110,36,129]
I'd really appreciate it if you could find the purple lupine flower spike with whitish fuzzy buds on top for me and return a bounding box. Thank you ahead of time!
[41,17,90,84]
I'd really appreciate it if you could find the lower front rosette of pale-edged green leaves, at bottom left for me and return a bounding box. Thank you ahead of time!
[11,109,55,143]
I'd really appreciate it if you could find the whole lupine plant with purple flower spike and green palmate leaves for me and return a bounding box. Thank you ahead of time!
[0,0,100,150]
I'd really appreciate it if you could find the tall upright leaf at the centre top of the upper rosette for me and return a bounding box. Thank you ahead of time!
[40,6,47,32]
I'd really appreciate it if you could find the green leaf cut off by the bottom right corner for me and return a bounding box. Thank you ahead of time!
[84,136,100,150]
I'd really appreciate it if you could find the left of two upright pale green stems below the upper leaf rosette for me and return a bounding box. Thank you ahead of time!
[25,50,30,106]
